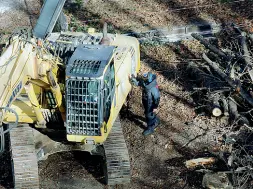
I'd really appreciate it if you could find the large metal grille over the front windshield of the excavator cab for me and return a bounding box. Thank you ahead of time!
[66,79,101,136]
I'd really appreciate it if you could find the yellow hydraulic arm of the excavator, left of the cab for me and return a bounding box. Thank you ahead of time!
[0,32,64,127]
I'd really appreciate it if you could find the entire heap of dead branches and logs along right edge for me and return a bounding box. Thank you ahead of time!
[186,24,253,189]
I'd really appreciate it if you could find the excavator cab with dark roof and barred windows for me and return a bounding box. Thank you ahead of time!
[65,45,115,139]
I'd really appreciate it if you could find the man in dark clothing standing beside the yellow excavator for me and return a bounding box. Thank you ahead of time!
[131,72,160,136]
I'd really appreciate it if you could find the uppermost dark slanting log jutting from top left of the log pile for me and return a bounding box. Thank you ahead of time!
[192,33,232,61]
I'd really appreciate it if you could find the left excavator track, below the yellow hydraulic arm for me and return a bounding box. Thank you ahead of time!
[10,124,39,189]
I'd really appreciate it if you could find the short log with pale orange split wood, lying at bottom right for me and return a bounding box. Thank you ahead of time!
[185,157,216,169]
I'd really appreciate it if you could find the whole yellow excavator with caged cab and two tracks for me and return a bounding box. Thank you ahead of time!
[0,0,140,189]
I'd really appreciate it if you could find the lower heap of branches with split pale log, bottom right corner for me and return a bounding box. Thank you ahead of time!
[185,125,253,189]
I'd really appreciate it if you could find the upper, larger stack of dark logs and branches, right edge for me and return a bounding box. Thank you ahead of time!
[188,25,253,125]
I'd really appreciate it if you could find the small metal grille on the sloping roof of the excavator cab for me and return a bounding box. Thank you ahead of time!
[70,60,101,74]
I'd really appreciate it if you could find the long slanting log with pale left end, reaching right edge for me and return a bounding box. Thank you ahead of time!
[203,53,253,106]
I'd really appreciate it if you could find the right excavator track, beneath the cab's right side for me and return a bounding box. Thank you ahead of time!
[104,117,131,185]
